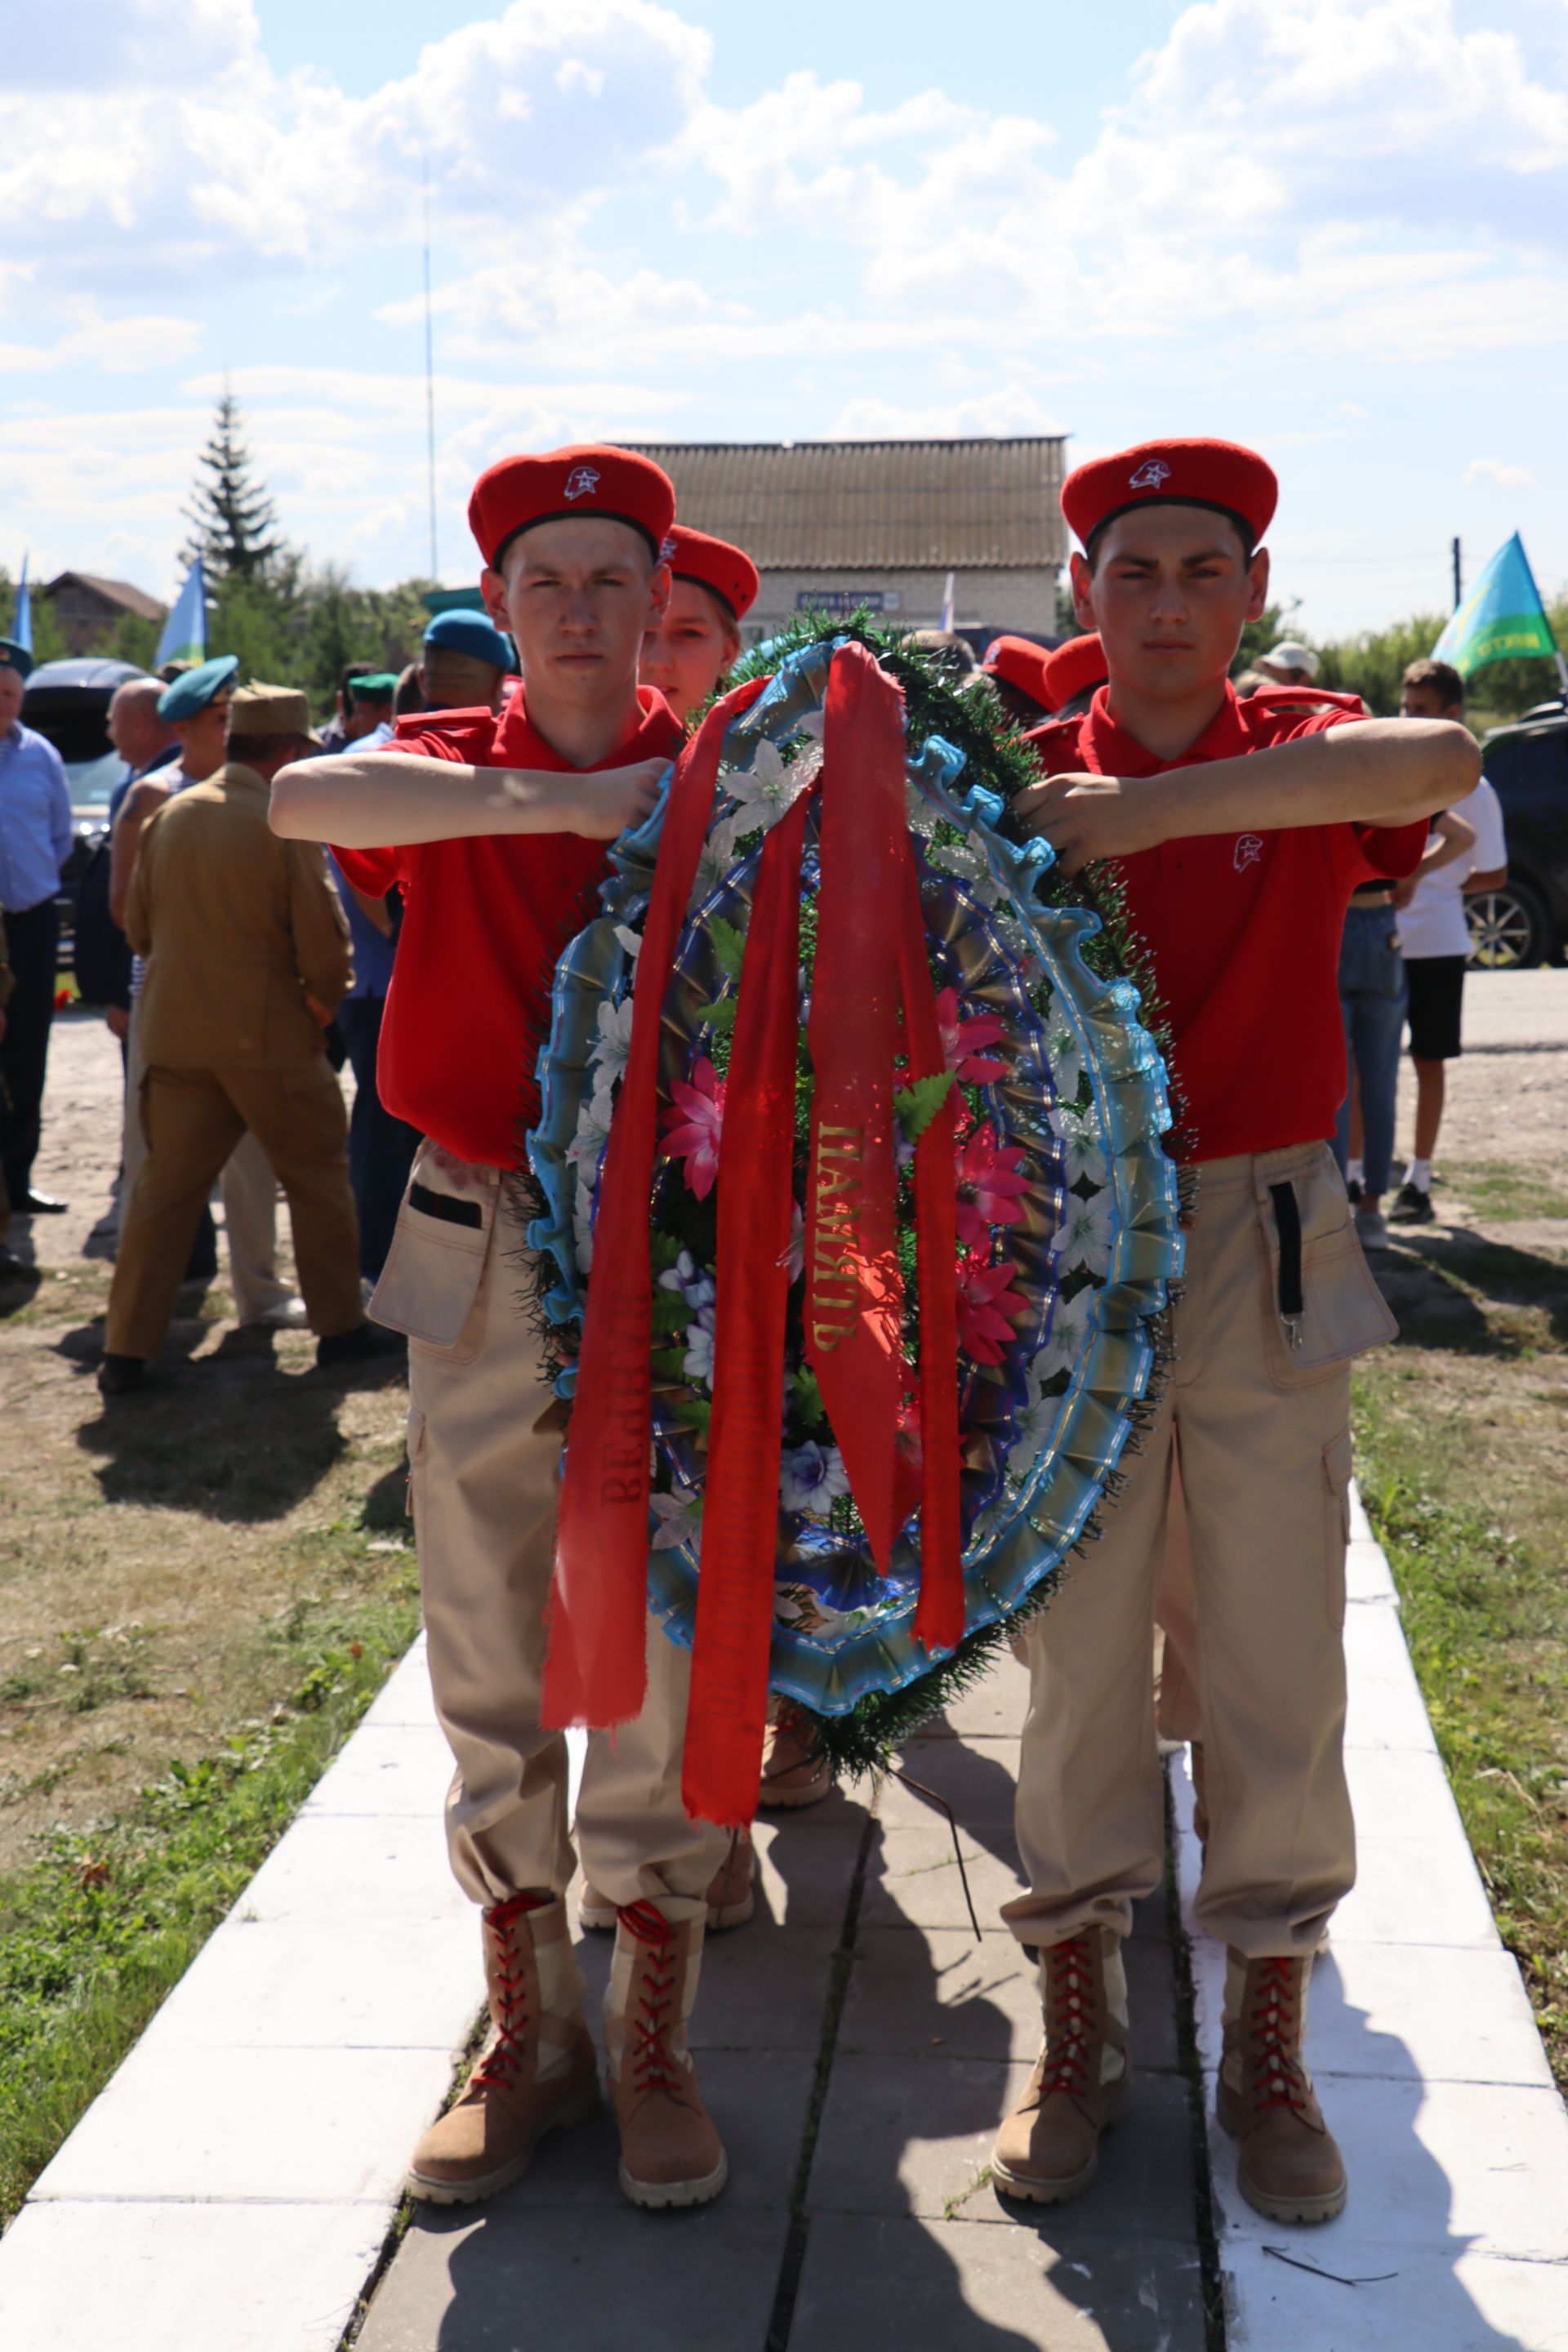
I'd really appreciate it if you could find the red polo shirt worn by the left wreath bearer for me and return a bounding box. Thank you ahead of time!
[334,687,684,1166]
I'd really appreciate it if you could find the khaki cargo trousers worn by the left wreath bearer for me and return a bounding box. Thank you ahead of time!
[372,1143,728,1922]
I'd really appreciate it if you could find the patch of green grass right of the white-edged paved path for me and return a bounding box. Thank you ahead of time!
[1354,1214,1568,2088]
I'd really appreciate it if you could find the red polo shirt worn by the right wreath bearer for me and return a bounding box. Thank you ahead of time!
[1030,687,1427,1160]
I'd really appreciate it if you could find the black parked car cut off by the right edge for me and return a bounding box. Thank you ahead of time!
[1464,703,1568,971]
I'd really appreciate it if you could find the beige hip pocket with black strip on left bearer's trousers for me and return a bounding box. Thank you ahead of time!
[369,1146,501,1364]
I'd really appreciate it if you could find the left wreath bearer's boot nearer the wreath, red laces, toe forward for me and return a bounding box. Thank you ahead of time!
[604,1903,728,2206]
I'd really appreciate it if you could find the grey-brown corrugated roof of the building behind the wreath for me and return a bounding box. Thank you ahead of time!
[635,435,1067,572]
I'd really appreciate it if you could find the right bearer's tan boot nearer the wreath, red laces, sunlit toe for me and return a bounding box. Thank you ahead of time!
[992,1927,1133,2204]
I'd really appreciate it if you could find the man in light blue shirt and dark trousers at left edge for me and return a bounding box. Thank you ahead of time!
[0,637,73,1216]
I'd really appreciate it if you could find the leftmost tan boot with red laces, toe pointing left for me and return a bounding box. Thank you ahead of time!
[407,1895,599,2204]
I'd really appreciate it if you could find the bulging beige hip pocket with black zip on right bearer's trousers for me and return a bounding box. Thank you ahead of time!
[1258,1147,1399,1388]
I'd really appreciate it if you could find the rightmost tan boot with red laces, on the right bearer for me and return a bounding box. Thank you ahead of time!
[1218,1952,1349,2221]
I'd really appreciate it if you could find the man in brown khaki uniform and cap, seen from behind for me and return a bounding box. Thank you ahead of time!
[99,684,399,1395]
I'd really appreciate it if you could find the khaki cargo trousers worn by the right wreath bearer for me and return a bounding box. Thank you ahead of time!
[1004,1143,1394,1957]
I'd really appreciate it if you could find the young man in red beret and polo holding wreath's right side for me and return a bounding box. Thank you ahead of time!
[995,442,1479,2221]
